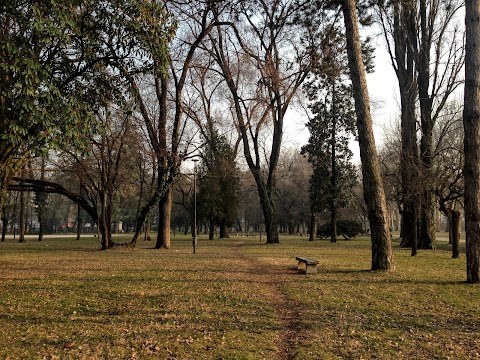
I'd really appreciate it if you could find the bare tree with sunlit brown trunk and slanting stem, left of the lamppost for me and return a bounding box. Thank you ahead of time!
[105,1,221,248]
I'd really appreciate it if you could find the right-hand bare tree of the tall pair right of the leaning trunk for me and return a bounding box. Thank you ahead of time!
[414,0,464,249]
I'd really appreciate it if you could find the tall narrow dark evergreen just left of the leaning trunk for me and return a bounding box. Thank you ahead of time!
[302,29,357,242]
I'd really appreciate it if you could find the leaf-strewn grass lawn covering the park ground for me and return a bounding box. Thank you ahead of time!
[0,235,480,359]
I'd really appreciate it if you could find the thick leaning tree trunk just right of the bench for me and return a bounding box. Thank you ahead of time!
[342,0,394,271]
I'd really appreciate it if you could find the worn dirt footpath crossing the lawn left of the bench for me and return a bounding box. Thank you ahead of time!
[231,242,305,360]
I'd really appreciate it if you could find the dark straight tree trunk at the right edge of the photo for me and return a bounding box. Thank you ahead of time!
[463,0,480,283]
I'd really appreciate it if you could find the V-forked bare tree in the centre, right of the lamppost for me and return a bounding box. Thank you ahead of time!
[210,0,320,243]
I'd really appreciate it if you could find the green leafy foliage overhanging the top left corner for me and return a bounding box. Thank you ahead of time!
[0,0,174,225]
